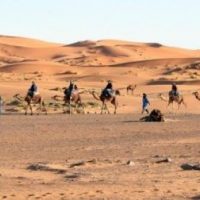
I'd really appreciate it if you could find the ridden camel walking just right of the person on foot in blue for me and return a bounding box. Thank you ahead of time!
[159,91,186,109]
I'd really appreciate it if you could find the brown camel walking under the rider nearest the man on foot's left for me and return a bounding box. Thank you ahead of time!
[91,90,120,114]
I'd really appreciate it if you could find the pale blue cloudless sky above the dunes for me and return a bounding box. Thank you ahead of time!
[0,0,200,49]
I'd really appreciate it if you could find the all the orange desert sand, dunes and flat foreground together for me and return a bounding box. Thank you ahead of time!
[0,36,200,200]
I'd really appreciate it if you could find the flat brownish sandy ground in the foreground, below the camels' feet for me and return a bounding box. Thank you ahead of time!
[0,114,200,200]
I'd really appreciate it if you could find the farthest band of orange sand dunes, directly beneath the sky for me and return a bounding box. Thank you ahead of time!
[0,36,200,70]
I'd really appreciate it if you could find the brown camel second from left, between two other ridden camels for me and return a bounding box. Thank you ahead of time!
[52,91,84,114]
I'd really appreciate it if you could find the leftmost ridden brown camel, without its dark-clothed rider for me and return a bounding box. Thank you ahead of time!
[13,94,47,115]
